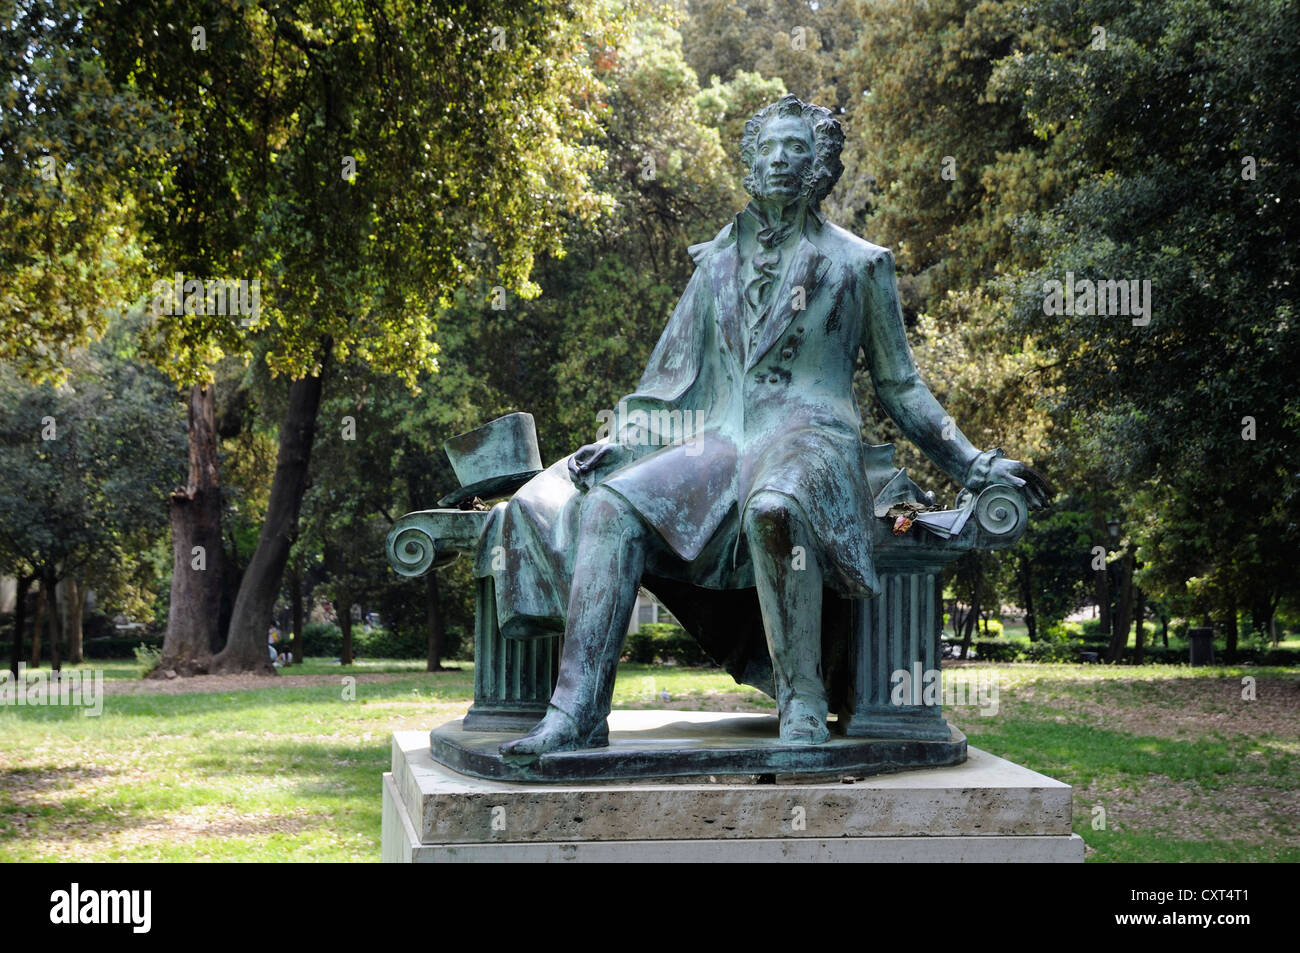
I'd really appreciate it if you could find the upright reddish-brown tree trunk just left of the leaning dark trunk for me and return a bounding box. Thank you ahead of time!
[158,384,224,679]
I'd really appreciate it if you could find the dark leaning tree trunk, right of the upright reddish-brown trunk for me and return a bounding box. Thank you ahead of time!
[211,368,324,675]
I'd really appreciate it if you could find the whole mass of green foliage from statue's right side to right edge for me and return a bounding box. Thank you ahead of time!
[849,0,1300,655]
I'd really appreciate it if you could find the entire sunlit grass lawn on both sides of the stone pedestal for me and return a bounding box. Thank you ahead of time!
[0,659,1300,861]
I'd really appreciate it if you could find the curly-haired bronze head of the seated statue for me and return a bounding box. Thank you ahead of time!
[740,95,844,208]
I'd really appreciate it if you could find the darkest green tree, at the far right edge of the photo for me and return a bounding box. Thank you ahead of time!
[995,0,1300,642]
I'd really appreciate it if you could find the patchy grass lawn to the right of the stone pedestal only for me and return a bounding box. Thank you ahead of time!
[949,664,1300,862]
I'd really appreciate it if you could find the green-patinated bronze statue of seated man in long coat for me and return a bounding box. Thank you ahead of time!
[476,96,1045,757]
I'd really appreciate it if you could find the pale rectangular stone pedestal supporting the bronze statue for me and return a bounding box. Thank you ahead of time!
[382,711,1083,862]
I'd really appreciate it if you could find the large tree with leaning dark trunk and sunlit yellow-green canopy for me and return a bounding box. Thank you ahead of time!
[86,0,618,671]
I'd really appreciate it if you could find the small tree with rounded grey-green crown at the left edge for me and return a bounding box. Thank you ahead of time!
[0,319,183,668]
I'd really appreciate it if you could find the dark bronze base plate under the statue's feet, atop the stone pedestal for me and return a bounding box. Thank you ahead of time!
[429,711,966,784]
